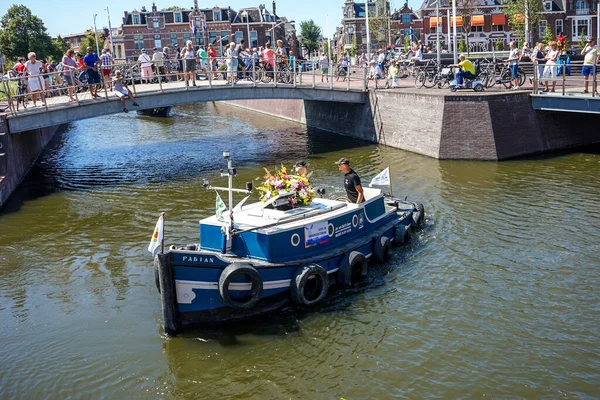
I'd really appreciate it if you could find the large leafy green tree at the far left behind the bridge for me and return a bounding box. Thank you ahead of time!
[0,5,54,59]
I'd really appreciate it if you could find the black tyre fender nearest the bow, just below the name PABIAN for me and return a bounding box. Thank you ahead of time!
[219,263,263,310]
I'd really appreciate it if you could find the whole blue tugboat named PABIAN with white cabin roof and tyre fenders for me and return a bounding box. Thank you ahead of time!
[149,152,425,335]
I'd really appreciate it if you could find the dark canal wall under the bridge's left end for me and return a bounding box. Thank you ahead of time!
[0,115,60,208]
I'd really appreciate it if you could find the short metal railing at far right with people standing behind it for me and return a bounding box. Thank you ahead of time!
[533,61,600,97]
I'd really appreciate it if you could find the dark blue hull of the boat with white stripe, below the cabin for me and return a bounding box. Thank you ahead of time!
[155,200,422,335]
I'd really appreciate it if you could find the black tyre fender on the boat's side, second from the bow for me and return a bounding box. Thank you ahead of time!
[290,264,329,306]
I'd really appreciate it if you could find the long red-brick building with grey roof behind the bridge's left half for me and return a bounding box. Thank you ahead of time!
[122,0,295,59]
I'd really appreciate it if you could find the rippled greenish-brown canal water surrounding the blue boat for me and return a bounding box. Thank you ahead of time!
[0,104,600,399]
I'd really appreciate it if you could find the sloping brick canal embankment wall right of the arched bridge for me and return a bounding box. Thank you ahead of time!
[227,88,600,161]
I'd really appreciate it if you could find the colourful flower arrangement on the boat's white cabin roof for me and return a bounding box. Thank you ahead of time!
[257,165,315,207]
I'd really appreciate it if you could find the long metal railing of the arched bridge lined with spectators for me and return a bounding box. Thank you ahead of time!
[0,57,367,115]
